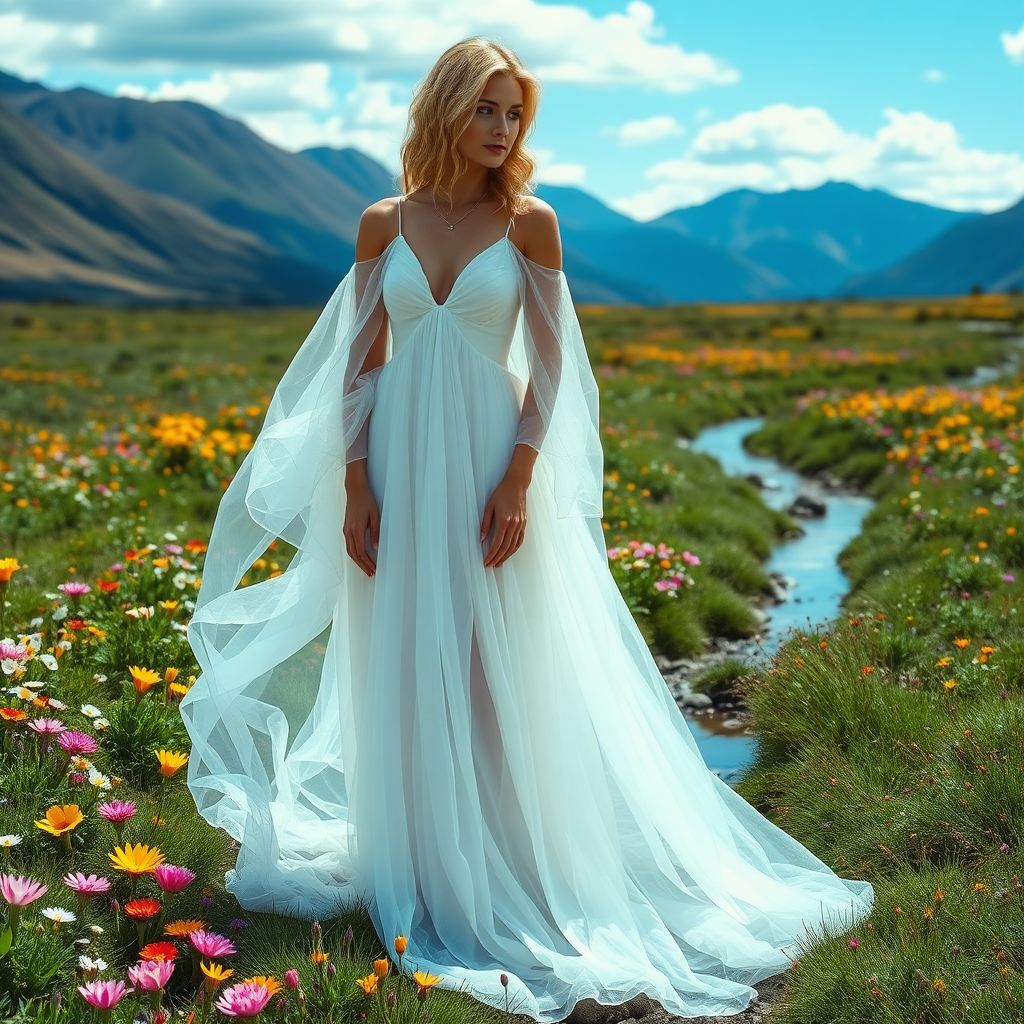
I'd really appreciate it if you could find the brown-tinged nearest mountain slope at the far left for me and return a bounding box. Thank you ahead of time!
[0,102,336,303]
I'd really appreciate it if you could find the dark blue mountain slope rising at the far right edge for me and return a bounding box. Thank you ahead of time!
[843,194,1024,296]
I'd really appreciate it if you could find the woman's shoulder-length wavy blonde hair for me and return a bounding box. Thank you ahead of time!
[399,36,541,217]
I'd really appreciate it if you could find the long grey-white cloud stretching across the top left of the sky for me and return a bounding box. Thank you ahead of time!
[0,0,739,92]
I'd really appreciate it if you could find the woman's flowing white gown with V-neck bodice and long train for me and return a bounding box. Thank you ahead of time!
[182,226,872,1022]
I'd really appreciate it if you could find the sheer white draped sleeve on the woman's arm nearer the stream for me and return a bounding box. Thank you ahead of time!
[509,246,604,524]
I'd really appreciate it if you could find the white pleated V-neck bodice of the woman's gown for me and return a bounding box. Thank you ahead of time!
[382,234,520,367]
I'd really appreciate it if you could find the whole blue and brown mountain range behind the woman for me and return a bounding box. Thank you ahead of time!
[0,72,1024,305]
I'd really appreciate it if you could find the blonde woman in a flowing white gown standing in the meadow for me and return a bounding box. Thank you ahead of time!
[182,39,872,1021]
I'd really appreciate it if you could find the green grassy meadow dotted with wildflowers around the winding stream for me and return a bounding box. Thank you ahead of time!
[0,296,1024,1024]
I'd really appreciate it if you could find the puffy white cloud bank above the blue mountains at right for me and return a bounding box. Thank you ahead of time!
[611,103,1024,220]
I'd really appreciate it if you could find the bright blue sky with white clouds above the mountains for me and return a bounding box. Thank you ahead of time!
[0,0,1024,220]
